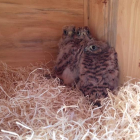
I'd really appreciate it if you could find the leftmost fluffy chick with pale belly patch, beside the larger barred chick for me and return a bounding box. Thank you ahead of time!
[54,26,81,86]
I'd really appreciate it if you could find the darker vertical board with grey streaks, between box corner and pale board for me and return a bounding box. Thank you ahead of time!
[88,0,118,47]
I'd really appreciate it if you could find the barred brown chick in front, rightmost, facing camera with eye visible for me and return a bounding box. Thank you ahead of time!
[77,40,119,106]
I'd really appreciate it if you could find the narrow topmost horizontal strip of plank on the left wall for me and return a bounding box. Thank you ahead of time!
[0,0,83,13]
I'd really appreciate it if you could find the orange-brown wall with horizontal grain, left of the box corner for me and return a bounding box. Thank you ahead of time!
[0,0,84,66]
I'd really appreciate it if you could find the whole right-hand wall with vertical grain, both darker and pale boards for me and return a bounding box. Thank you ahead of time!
[86,0,140,83]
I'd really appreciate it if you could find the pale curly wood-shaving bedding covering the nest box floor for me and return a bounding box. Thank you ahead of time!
[0,64,140,140]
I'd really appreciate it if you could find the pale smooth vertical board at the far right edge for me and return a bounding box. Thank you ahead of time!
[116,0,140,83]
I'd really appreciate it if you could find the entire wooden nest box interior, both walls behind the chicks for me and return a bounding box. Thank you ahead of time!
[0,0,140,83]
